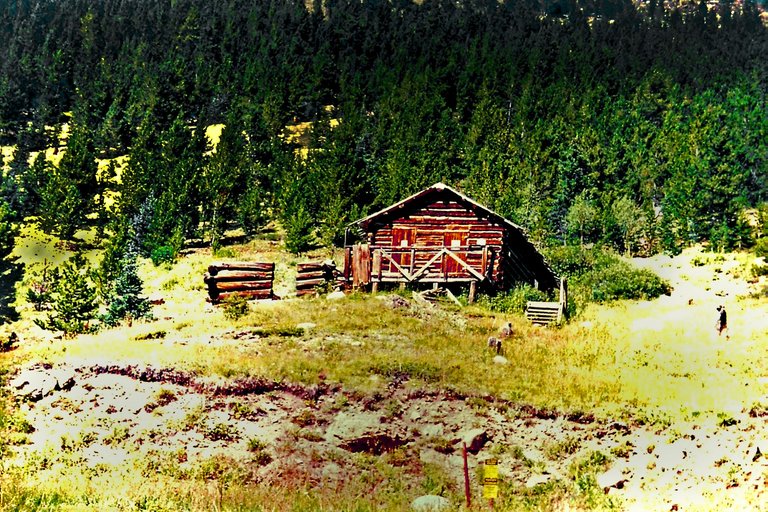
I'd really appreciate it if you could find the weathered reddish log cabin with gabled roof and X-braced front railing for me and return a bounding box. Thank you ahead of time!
[344,183,559,301]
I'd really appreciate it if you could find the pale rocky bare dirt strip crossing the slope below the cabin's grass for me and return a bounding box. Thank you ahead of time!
[13,365,768,510]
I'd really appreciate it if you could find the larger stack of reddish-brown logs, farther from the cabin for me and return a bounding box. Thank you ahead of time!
[203,262,277,303]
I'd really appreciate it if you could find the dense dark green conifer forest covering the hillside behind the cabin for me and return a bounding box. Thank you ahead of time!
[0,0,768,261]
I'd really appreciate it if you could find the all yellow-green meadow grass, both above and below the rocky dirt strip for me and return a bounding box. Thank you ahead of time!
[0,218,768,511]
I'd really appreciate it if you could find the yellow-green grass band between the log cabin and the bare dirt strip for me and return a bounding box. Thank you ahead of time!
[7,223,768,420]
